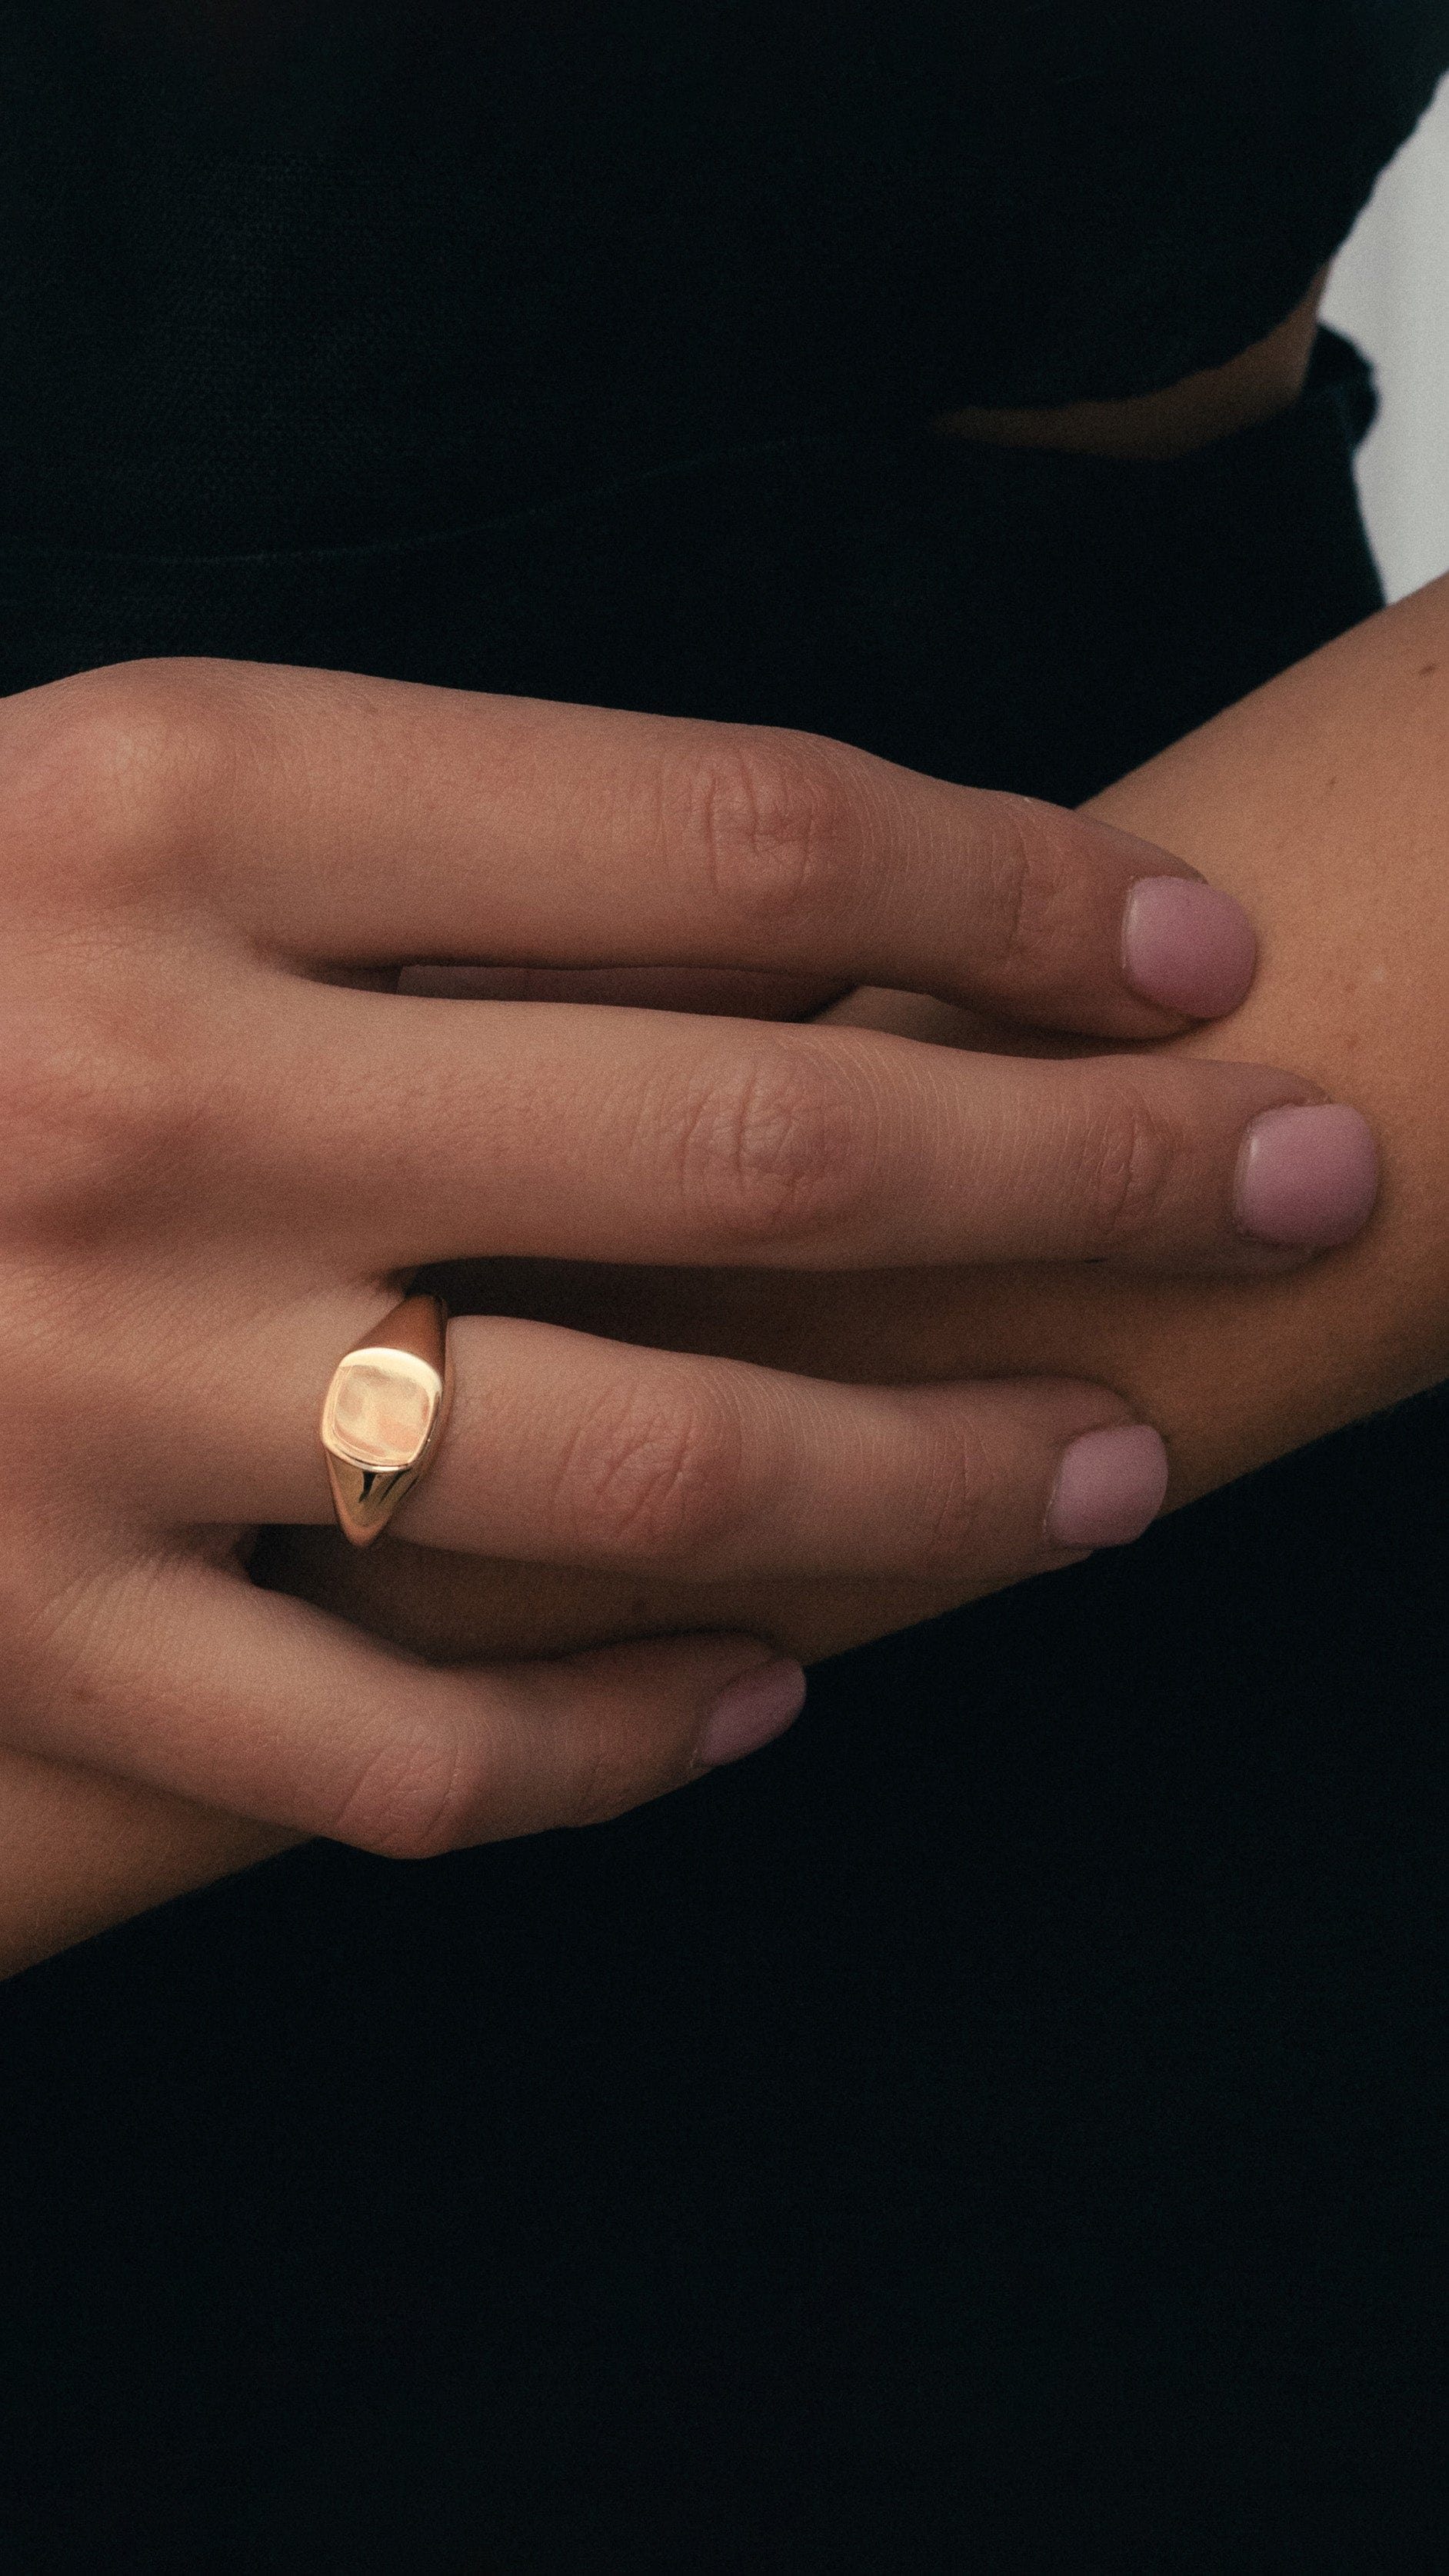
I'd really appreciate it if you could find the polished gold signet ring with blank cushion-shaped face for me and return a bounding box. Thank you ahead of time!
[321,1296,453,1548]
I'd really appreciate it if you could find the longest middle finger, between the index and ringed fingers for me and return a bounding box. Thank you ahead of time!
[247,981,1377,1272]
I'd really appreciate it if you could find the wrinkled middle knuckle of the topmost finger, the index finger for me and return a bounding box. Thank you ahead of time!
[679,726,857,932]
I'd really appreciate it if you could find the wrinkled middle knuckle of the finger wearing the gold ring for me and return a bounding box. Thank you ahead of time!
[564,1378,744,1564]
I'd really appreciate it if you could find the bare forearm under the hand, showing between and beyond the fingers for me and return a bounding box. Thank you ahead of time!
[17,582,1449,1965]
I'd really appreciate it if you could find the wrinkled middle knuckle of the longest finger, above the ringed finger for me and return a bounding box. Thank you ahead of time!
[679,1041,875,1247]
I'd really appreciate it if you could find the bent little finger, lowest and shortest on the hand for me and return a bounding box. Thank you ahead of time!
[8,1558,805,1860]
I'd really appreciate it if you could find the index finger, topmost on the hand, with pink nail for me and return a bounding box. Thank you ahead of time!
[93,665,1254,1038]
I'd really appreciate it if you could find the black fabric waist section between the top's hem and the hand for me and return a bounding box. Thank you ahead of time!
[0,332,1380,804]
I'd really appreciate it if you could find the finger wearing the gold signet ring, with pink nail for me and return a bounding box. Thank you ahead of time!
[145,1316,1166,1581]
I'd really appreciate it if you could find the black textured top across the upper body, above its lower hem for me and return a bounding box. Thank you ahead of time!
[0,0,1449,552]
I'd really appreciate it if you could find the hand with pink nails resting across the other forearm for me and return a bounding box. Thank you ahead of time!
[0,665,1372,1852]
